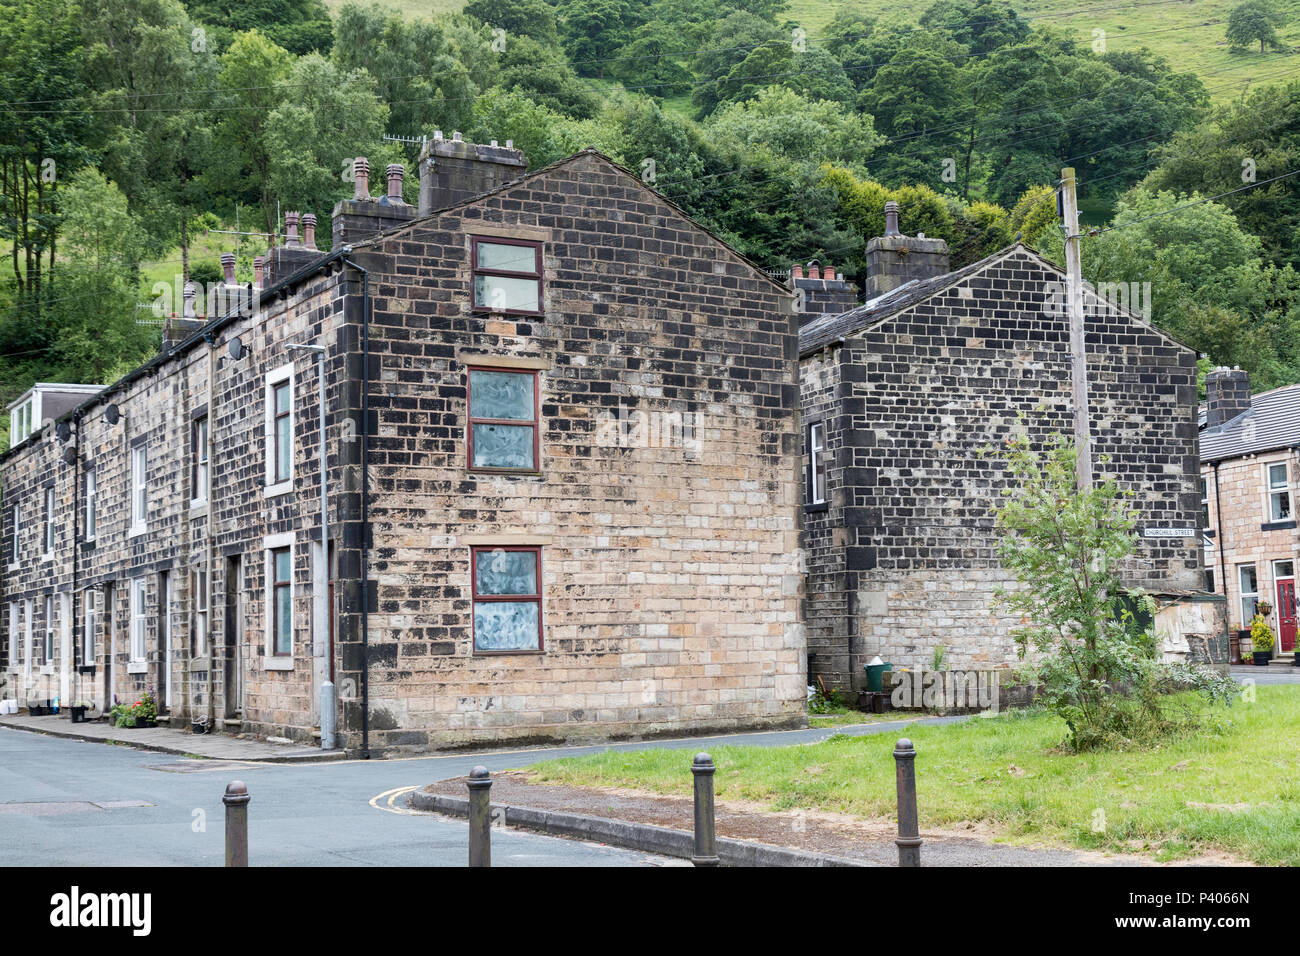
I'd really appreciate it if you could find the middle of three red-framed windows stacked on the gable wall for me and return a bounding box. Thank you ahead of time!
[465,365,542,471]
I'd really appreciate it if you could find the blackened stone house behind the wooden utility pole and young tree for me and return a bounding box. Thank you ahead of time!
[800,203,1227,689]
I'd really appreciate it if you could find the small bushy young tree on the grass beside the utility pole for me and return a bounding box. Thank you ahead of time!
[997,423,1236,750]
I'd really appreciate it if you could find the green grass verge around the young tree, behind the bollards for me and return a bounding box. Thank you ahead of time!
[530,687,1300,865]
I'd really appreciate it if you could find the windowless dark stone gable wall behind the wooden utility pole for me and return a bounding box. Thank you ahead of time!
[805,247,1201,685]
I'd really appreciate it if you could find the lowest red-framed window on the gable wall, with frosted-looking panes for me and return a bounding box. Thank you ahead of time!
[469,545,542,654]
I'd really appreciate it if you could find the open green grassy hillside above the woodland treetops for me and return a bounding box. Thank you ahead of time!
[325,0,1300,103]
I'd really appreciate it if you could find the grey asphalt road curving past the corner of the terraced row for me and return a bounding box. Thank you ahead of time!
[0,718,954,866]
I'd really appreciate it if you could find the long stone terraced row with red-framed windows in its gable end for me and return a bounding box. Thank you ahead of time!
[0,134,806,753]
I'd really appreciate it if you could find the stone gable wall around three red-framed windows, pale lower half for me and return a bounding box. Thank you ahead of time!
[343,153,806,748]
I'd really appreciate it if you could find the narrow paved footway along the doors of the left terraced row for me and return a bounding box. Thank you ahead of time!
[0,713,347,763]
